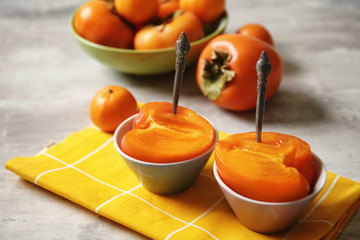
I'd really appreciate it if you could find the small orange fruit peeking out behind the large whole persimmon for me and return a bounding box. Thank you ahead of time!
[236,23,275,46]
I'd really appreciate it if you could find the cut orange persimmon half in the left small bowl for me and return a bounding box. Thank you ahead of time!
[120,102,215,163]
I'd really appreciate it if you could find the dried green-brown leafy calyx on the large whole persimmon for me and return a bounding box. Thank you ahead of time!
[200,49,235,101]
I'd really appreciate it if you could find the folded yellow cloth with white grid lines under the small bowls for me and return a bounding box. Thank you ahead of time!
[6,127,360,240]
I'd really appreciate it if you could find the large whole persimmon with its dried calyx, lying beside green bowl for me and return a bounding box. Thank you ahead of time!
[196,34,283,111]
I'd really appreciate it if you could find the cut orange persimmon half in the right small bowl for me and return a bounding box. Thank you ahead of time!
[214,132,315,202]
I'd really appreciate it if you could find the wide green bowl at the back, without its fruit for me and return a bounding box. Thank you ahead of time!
[70,13,228,75]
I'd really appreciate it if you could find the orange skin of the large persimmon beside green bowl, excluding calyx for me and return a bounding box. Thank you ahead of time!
[196,34,284,111]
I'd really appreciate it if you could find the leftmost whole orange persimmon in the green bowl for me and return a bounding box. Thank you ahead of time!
[73,0,134,48]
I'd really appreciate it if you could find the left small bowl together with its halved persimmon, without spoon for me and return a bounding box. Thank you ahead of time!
[114,102,218,195]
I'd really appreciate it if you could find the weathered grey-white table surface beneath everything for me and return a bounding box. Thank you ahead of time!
[0,0,360,239]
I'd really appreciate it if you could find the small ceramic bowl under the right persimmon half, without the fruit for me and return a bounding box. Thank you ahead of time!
[213,154,326,233]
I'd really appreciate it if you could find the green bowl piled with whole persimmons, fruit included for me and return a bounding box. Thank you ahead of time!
[70,0,228,75]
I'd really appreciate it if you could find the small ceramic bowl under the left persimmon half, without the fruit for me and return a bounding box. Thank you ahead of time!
[114,114,219,195]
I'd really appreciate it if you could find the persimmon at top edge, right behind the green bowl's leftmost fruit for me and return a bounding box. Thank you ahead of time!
[114,0,159,25]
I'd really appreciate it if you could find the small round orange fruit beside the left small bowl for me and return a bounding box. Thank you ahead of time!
[90,85,139,133]
